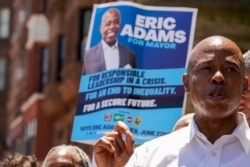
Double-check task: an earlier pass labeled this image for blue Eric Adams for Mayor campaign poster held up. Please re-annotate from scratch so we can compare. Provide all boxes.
[71,2,197,144]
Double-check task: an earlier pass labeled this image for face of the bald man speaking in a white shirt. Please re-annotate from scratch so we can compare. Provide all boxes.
[183,37,247,119]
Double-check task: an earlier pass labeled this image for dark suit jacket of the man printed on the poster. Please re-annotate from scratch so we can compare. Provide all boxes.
[83,42,136,74]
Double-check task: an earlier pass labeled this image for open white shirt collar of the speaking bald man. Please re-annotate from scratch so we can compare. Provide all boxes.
[188,112,250,154]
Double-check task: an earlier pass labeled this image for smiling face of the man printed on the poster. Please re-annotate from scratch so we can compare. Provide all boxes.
[100,10,120,45]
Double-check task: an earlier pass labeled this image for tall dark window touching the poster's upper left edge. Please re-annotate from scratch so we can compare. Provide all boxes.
[77,9,92,60]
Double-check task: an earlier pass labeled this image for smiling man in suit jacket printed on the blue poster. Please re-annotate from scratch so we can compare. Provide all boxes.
[83,8,136,74]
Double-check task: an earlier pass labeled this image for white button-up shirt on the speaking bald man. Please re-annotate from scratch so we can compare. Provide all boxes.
[126,113,250,167]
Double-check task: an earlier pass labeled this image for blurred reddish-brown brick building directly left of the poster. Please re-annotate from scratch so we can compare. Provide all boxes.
[7,0,115,159]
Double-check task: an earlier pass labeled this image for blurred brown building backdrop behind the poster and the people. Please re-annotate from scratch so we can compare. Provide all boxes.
[0,0,250,160]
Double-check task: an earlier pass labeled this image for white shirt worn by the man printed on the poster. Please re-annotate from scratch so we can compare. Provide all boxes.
[102,40,120,70]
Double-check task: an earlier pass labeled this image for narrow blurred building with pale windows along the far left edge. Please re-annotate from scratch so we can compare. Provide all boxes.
[0,0,12,158]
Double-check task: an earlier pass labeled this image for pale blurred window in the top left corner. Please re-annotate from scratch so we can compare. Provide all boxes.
[0,8,10,38]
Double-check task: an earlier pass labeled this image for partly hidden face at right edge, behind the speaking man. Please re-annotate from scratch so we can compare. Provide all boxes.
[239,71,250,126]
